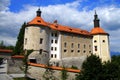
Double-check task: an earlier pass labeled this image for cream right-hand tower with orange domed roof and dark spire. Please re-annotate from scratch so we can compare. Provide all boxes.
[91,12,111,62]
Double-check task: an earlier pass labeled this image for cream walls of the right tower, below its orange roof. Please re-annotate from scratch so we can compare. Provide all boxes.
[93,35,110,62]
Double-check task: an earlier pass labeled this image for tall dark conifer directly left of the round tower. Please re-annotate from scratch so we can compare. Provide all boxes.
[13,23,26,55]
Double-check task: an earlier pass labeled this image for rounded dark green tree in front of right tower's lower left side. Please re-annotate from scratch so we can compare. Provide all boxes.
[76,54,102,80]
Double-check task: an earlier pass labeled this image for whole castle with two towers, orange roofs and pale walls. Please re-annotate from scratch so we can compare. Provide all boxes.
[24,9,110,64]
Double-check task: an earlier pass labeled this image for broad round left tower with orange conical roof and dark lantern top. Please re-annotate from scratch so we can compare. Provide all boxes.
[24,9,50,64]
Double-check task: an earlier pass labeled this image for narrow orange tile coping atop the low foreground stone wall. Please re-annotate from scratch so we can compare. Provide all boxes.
[28,63,80,73]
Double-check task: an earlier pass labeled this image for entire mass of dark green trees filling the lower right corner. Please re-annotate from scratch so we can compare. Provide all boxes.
[76,55,120,80]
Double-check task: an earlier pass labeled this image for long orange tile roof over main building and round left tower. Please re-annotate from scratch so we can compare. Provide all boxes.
[28,16,90,35]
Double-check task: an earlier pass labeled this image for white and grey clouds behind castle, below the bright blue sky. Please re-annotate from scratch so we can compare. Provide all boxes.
[0,1,120,52]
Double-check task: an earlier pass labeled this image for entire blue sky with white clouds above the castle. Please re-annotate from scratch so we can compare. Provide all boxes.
[0,0,120,54]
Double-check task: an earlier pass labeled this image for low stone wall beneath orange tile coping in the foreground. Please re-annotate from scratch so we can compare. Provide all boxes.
[28,66,78,80]
